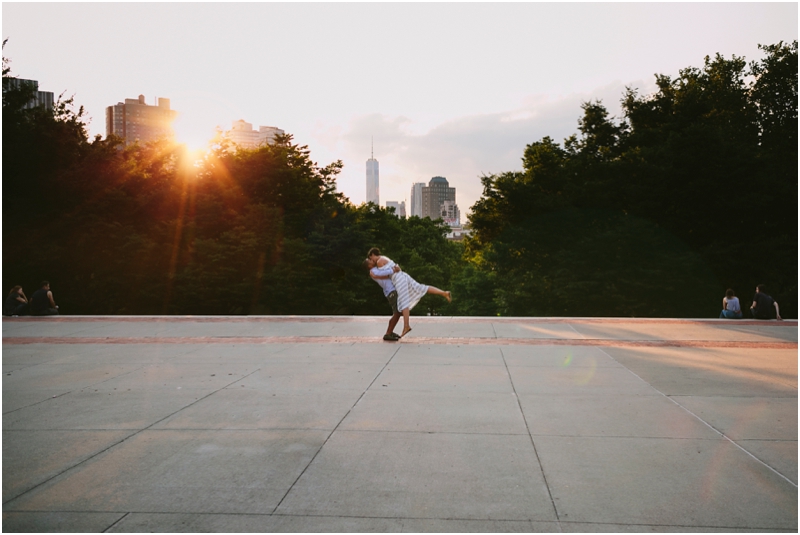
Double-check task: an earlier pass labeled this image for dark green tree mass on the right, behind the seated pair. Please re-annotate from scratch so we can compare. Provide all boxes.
[454,41,797,317]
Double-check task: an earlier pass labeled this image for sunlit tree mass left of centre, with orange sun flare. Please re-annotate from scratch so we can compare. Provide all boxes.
[3,45,461,315]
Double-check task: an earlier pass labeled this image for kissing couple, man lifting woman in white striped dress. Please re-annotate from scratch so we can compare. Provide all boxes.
[364,247,451,342]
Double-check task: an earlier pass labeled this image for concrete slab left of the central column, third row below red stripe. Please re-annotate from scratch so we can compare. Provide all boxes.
[152,385,361,431]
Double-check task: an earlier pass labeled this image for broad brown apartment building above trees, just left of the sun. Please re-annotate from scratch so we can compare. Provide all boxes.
[106,95,178,145]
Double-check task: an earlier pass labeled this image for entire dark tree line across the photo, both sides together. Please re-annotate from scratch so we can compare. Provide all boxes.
[3,42,797,317]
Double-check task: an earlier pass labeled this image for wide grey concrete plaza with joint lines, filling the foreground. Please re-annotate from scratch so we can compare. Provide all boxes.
[2,316,798,532]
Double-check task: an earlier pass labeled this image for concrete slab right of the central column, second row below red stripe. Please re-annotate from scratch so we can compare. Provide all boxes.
[508,366,660,396]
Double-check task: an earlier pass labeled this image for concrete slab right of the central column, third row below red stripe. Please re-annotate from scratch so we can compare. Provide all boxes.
[519,394,719,439]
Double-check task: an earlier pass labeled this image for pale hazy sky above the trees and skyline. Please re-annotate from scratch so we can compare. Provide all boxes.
[2,2,798,220]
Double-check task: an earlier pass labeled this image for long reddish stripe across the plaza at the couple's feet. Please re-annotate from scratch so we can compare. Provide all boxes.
[3,336,797,350]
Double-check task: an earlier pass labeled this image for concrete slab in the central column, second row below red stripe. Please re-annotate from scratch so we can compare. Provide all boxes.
[373,364,513,393]
